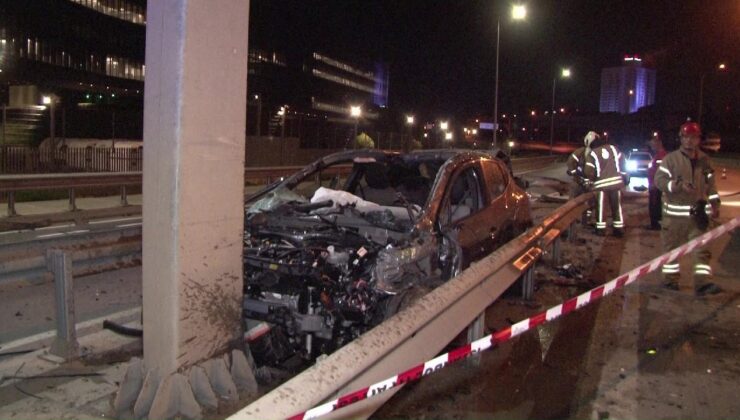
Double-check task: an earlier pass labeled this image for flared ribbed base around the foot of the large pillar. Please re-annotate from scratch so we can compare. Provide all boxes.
[113,350,259,420]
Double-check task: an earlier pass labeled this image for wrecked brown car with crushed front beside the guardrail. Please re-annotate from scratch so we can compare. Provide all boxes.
[244,150,532,367]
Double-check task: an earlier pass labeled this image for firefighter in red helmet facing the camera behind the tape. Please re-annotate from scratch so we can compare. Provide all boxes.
[655,121,720,296]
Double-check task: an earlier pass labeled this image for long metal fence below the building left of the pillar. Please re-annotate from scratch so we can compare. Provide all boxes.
[0,146,143,174]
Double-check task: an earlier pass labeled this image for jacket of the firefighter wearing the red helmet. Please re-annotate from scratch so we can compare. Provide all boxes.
[655,150,720,217]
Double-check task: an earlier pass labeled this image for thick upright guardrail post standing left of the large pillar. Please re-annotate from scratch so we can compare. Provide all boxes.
[46,249,80,360]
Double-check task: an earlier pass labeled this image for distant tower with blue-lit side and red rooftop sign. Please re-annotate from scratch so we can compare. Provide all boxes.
[599,56,655,114]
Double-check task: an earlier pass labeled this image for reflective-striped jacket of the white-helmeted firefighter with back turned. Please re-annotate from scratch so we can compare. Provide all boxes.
[584,139,625,191]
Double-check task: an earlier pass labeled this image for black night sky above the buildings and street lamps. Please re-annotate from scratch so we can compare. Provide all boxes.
[250,0,740,123]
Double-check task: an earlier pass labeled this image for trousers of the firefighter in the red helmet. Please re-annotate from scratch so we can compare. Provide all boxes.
[660,214,712,289]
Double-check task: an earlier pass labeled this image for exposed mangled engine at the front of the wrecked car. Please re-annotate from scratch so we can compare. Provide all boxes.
[244,203,416,366]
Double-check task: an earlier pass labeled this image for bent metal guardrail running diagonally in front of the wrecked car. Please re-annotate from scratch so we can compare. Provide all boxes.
[229,193,593,420]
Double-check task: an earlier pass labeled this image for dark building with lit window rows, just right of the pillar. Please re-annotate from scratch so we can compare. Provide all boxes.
[247,50,388,148]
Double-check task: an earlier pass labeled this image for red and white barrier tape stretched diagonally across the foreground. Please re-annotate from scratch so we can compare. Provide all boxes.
[289,217,740,420]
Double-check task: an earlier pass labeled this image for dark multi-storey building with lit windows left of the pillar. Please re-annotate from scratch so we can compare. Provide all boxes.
[0,0,146,145]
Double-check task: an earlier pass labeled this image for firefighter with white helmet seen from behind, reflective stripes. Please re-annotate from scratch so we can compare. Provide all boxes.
[585,131,627,238]
